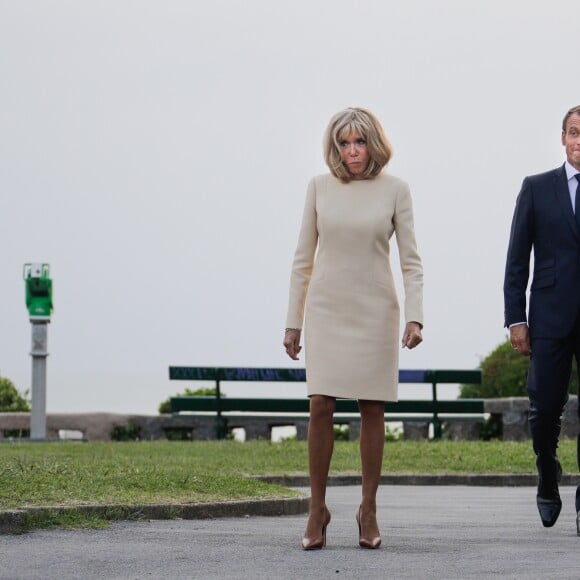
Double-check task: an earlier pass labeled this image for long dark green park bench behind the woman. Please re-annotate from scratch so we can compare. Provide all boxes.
[169,366,484,439]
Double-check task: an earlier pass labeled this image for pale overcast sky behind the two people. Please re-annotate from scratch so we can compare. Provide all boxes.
[0,0,580,413]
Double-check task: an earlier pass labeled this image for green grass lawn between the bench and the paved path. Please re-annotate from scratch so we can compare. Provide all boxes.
[0,440,576,532]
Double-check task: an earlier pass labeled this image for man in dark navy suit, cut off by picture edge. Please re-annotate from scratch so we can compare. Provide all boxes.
[504,106,580,535]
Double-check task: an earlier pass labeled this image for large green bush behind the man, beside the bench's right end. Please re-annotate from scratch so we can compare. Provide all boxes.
[459,339,578,399]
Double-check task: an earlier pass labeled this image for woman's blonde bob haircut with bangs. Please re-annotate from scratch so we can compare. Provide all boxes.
[323,107,393,183]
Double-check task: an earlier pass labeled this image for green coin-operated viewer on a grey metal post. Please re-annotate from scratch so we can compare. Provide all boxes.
[24,263,52,440]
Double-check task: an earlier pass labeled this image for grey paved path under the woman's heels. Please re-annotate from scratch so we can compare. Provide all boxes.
[0,486,580,580]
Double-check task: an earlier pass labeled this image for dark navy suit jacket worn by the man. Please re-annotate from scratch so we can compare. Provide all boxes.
[504,166,580,338]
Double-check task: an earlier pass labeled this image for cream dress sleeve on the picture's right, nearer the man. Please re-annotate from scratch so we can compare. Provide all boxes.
[394,184,423,325]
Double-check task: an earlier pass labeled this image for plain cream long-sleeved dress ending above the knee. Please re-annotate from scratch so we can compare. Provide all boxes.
[286,172,423,401]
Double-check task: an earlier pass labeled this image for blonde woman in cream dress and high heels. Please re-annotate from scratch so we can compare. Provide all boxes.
[284,108,423,550]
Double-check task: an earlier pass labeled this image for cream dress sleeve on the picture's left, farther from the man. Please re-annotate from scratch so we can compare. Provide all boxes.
[286,179,318,328]
